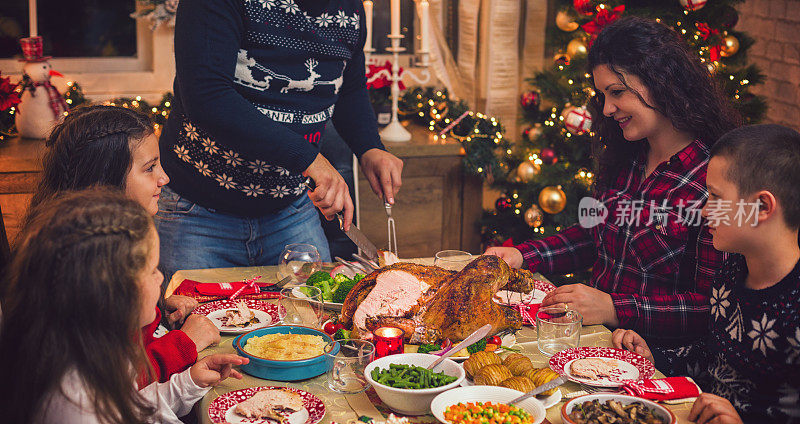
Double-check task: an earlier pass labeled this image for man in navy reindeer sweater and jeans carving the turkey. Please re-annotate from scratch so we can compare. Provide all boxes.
[157,0,403,280]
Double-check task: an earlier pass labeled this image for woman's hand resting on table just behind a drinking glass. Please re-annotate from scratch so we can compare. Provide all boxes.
[542,284,619,327]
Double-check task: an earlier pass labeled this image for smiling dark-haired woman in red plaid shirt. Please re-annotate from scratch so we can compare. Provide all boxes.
[486,17,737,362]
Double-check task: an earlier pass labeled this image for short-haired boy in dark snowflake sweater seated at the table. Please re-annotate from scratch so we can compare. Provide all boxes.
[613,125,800,423]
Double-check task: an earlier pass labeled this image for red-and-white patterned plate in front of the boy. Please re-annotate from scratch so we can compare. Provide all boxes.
[550,347,656,387]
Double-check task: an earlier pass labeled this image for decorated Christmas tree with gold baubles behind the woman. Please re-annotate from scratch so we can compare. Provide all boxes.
[481,0,766,284]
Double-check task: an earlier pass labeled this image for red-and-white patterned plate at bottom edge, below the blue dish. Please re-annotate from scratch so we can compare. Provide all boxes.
[208,386,325,424]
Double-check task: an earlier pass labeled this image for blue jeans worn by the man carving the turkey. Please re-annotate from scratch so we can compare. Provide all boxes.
[155,186,331,284]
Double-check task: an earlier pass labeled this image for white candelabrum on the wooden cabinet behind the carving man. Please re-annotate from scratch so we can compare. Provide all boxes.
[364,34,431,143]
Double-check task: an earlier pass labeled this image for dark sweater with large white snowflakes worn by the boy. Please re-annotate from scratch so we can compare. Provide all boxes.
[676,255,800,423]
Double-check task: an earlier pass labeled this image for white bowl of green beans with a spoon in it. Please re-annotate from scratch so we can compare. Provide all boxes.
[364,353,465,415]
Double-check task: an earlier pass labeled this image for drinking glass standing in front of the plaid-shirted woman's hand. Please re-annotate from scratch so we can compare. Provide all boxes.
[536,307,583,356]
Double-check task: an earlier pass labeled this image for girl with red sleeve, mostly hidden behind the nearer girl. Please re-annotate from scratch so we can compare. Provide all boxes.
[31,106,220,382]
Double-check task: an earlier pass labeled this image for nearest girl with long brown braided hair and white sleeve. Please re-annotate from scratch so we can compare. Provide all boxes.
[0,189,248,424]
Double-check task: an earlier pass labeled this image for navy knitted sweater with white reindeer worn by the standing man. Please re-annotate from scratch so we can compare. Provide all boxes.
[160,0,383,216]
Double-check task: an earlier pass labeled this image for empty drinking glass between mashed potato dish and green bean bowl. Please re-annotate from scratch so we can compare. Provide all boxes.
[325,339,375,394]
